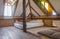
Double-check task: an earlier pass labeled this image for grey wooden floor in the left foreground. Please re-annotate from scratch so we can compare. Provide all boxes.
[0,27,40,39]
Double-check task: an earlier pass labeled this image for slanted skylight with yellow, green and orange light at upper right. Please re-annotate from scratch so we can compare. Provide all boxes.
[34,0,56,15]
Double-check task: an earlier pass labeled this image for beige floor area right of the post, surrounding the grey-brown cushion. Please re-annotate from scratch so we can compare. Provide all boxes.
[27,27,55,39]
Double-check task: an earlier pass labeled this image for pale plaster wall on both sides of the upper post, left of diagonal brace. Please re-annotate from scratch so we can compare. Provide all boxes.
[15,0,30,16]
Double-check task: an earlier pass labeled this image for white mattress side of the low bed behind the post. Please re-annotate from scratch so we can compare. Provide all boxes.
[14,23,43,28]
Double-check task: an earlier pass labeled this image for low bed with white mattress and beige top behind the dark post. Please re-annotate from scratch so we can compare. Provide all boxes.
[14,20,44,29]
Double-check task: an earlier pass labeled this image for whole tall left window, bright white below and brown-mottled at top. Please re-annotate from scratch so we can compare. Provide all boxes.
[4,0,16,16]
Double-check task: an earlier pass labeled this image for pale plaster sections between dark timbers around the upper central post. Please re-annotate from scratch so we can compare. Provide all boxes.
[14,0,45,16]
